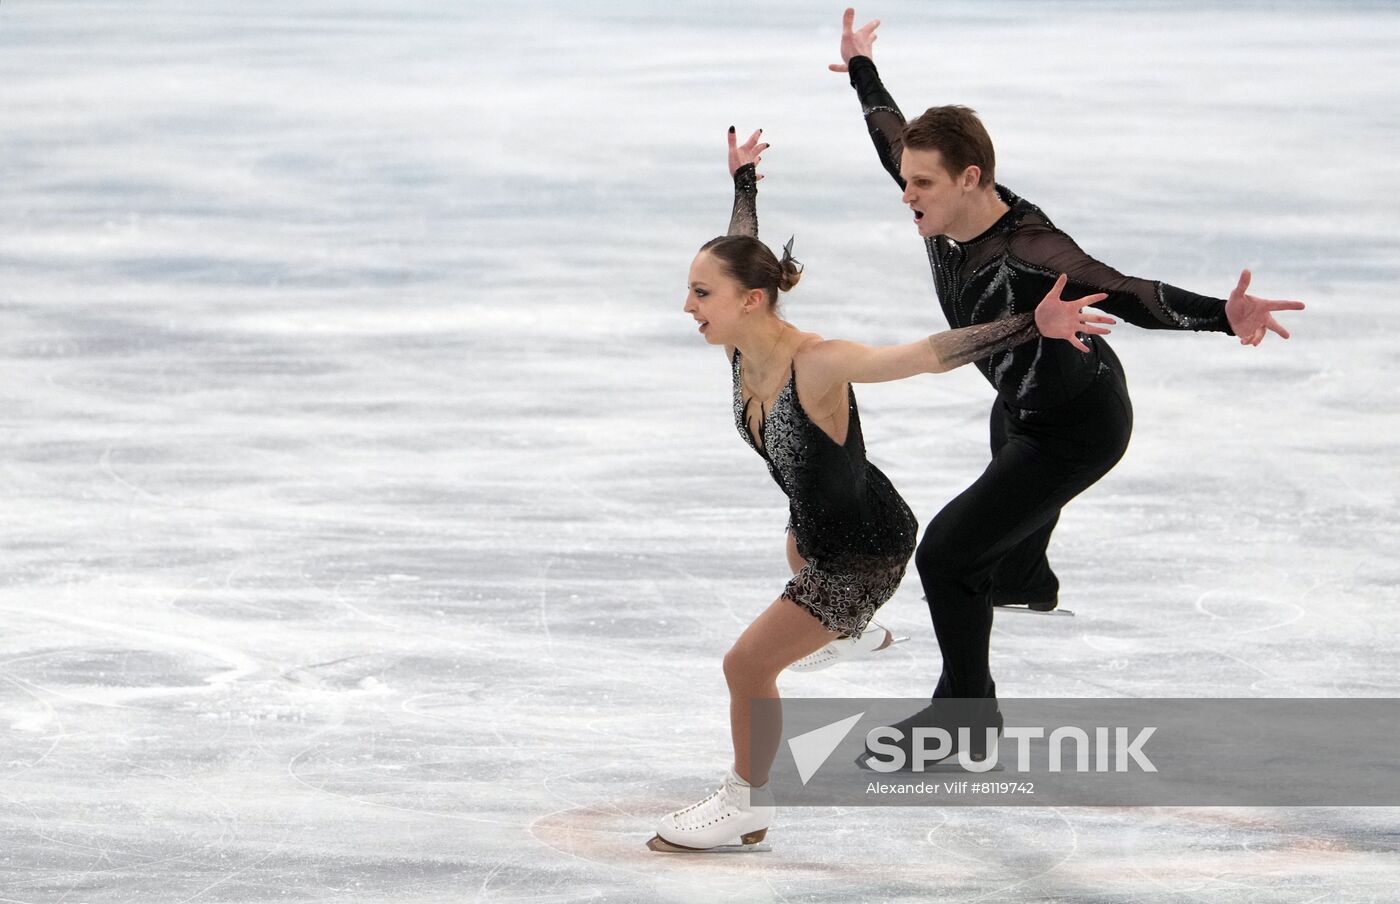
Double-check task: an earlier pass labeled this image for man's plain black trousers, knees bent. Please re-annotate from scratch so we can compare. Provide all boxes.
[914,354,1133,697]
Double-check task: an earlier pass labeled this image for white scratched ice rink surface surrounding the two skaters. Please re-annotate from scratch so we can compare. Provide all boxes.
[0,0,1400,904]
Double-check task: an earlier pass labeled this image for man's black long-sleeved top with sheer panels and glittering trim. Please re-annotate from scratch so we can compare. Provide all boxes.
[850,56,1231,409]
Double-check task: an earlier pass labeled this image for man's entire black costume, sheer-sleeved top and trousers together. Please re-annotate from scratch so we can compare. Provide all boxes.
[848,56,1231,697]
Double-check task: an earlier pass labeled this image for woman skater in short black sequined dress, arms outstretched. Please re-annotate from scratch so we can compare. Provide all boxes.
[648,127,1114,851]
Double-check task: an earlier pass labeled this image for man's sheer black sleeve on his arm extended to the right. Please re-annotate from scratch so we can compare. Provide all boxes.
[1011,225,1233,336]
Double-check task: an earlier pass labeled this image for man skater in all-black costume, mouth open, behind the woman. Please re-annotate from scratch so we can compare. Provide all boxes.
[830,10,1303,756]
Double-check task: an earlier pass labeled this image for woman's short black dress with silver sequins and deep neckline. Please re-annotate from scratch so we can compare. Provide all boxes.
[732,348,918,635]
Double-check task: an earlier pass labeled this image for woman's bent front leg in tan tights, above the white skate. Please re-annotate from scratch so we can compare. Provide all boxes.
[724,596,839,785]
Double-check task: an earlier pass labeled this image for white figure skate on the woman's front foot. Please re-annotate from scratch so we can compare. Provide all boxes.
[647,768,773,854]
